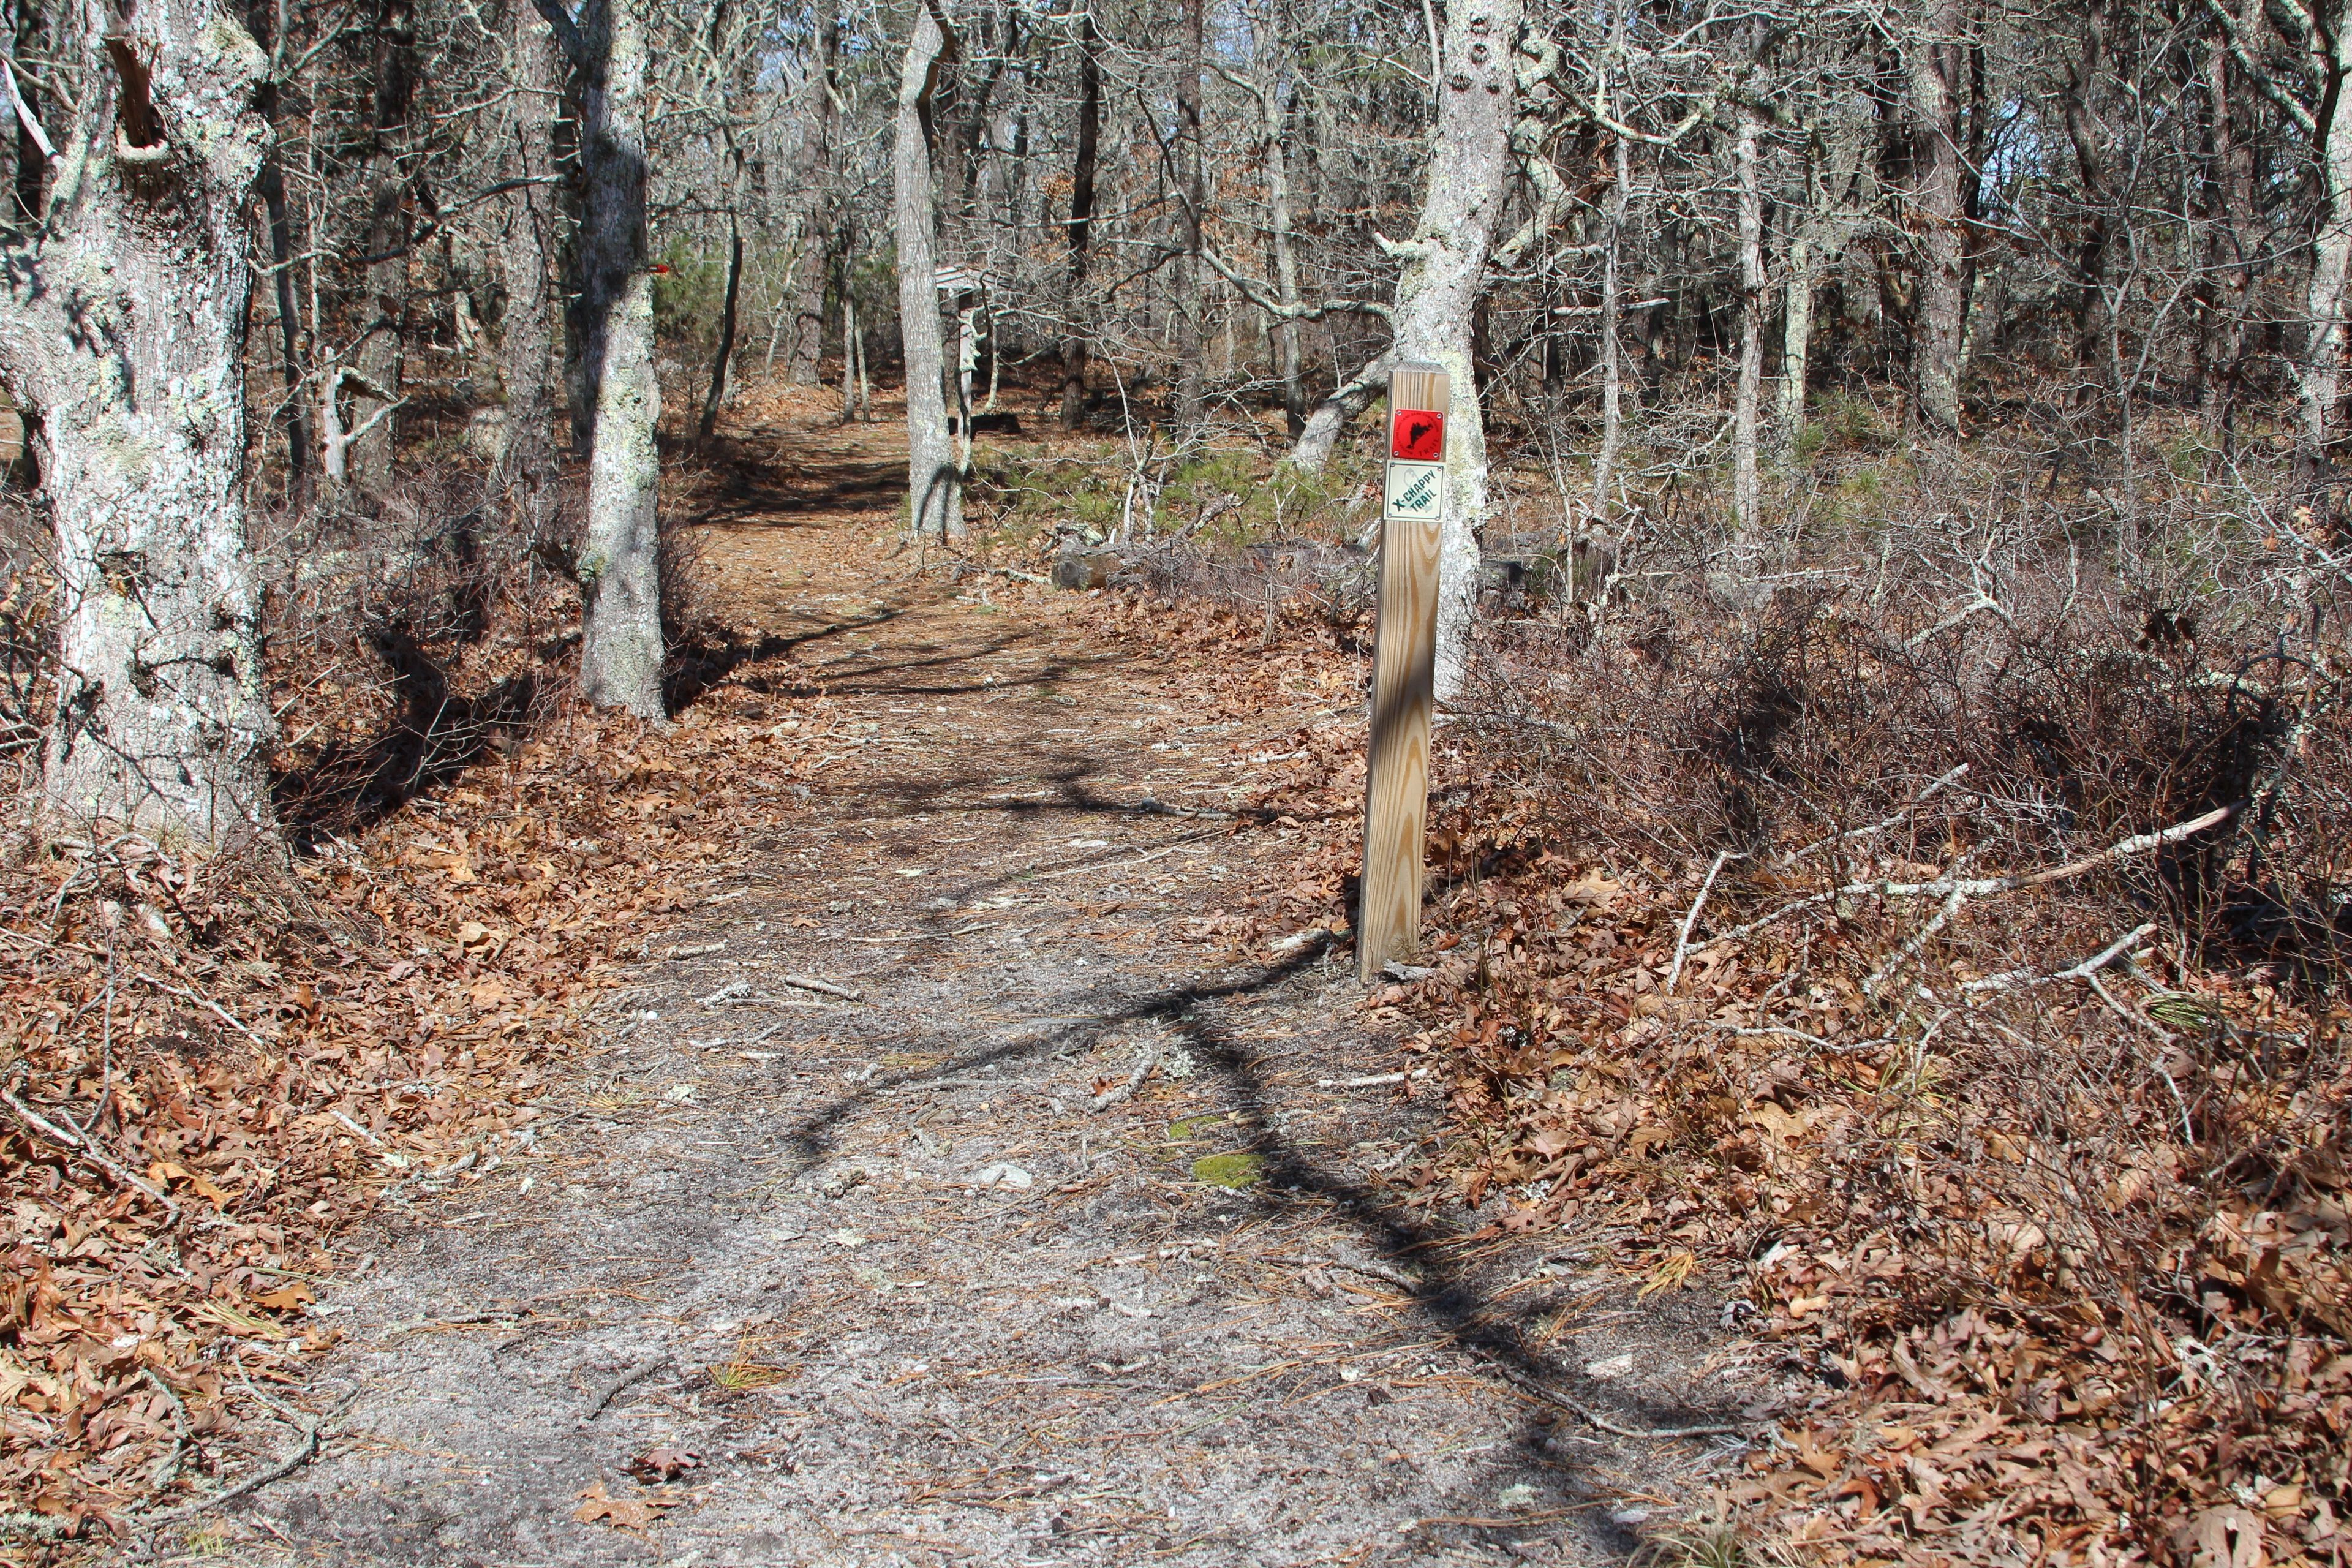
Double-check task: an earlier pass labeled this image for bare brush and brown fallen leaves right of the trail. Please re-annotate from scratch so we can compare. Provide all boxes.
[1411,481,2352,1566]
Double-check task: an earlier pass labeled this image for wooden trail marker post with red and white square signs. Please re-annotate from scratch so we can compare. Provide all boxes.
[1355,364,1453,985]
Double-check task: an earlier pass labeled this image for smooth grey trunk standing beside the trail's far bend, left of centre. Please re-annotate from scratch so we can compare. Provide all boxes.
[891,7,964,538]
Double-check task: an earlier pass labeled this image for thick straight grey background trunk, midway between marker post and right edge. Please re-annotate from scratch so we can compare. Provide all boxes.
[1903,0,1966,435]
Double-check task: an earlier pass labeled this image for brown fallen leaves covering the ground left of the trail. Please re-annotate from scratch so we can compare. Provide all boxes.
[0,665,831,1545]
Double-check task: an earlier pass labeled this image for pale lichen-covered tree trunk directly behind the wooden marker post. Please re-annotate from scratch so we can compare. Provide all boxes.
[1382,0,1521,701]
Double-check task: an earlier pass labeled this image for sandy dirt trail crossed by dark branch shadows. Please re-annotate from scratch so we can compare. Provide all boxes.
[214,409,1750,1568]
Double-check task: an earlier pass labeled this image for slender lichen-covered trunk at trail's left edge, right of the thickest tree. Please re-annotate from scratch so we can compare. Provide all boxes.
[581,0,666,722]
